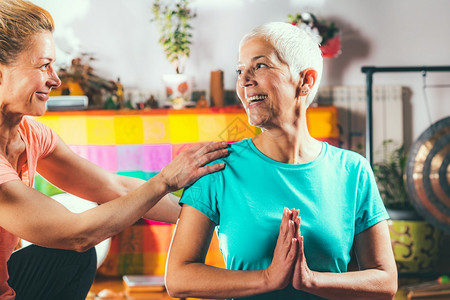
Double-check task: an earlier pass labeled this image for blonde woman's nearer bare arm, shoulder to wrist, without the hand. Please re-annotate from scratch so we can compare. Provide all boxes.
[0,171,167,251]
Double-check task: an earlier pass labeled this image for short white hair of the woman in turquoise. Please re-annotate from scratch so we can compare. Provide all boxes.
[239,22,323,106]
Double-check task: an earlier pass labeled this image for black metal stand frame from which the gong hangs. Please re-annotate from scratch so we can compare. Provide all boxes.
[361,66,450,165]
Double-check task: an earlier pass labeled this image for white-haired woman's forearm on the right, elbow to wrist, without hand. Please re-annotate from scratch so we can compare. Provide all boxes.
[304,269,397,300]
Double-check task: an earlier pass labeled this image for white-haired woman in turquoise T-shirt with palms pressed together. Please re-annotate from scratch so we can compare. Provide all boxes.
[166,22,397,300]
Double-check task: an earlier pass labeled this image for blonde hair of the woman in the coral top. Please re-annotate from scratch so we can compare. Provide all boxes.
[0,0,55,65]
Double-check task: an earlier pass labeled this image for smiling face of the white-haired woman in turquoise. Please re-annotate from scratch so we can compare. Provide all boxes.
[236,37,299,129]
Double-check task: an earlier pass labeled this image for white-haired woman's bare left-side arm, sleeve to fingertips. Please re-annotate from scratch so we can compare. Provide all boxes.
[166,205,297,298]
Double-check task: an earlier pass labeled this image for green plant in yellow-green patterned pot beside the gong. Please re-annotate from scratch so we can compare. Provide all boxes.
[373,140,442,273]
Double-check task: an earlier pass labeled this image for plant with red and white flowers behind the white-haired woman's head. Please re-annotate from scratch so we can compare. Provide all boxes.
[288,12,341,58]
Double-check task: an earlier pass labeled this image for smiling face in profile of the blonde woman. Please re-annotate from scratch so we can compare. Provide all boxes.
[0,32,61,116]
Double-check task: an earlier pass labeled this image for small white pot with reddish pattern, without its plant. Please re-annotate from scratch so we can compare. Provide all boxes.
[162,74,192,109]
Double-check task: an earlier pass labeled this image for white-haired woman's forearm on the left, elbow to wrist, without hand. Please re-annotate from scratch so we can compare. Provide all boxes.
[166,263,271,299]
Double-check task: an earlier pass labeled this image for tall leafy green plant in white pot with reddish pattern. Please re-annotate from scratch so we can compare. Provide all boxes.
[152,0,197,108]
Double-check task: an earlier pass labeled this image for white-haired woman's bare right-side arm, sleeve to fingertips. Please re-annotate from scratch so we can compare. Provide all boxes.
[293,221,397,299]
